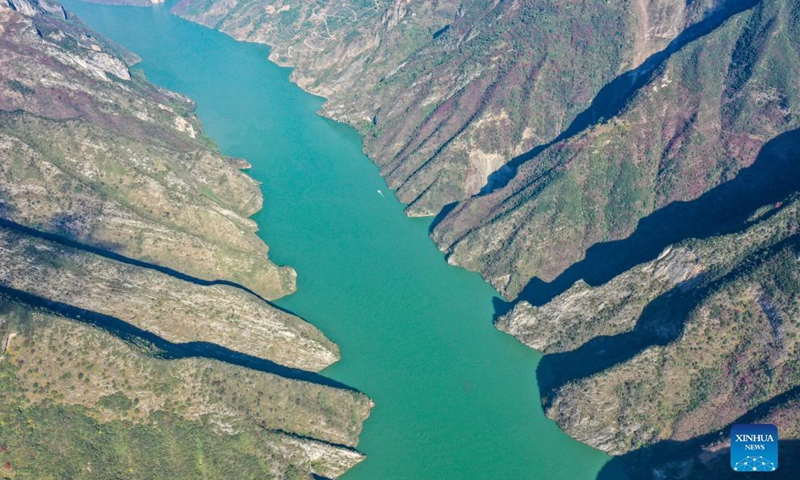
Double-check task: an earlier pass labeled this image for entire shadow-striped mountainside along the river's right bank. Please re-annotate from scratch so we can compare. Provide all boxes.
[164,0,800,478]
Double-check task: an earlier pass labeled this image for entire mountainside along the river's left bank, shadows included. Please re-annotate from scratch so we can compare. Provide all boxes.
[0,0,372,479]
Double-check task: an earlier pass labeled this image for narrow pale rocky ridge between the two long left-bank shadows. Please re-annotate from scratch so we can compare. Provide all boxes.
[0,227,339,371]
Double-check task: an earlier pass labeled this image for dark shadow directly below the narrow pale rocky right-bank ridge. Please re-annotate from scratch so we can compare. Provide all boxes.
[537,235,800,398]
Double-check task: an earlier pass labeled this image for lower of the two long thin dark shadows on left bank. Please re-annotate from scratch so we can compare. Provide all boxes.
[0,285,358,392]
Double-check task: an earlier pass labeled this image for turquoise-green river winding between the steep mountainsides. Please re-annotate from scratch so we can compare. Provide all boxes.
[65,1,620,480]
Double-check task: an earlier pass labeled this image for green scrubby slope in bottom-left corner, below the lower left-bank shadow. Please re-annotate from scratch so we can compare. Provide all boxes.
[0,294,370,480]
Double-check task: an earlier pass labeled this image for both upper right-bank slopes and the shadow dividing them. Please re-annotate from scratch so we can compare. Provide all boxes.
[167,0,797,298]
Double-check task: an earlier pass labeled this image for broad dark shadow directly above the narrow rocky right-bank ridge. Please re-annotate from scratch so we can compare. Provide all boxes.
[510,125,800,313]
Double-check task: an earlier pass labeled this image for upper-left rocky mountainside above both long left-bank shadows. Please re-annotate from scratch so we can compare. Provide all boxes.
[0,0,295,299]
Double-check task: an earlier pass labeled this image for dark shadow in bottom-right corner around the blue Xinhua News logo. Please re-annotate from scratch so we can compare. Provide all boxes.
[597,387,800,480]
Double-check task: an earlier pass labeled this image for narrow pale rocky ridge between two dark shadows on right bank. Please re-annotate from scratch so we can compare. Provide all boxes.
[497,197,800,353]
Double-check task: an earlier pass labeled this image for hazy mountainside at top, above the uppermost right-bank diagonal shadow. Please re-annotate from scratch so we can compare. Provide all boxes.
[173,0,719,215]
